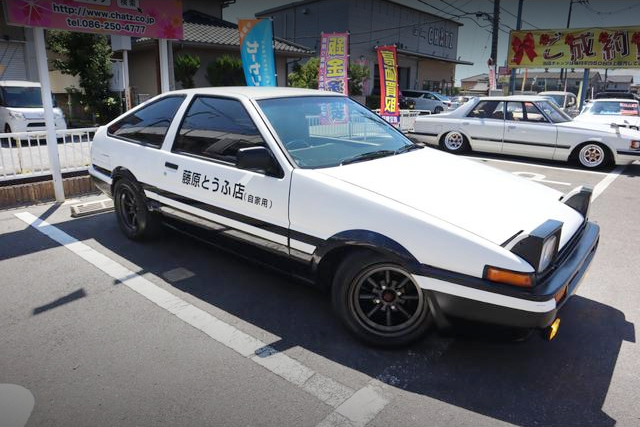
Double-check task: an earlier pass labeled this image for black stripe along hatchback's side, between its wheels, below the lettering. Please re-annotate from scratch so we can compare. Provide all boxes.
[142,184,324,246]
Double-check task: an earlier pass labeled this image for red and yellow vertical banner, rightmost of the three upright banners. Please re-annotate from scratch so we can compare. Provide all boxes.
[378,46,400,124]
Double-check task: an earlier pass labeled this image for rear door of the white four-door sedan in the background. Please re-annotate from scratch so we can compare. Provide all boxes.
[460,100,504,153]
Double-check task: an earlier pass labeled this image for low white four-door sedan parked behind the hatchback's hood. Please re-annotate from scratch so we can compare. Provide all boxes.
[410,96,640,168]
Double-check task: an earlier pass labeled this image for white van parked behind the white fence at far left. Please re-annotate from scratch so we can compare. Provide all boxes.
[0,80,67,133]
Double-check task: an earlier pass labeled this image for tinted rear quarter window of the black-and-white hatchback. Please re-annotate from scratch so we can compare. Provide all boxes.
[107,96,184,148]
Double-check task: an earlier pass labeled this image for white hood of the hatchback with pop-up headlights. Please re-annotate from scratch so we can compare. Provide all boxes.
[318,148,583,246]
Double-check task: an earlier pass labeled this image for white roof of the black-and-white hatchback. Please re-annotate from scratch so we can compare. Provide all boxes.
[161,86,346,99]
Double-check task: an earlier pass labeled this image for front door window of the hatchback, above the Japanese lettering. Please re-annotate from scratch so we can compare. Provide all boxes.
[171,96,265,165]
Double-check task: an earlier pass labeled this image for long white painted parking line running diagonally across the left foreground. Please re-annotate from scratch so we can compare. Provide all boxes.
[14,212,392,426]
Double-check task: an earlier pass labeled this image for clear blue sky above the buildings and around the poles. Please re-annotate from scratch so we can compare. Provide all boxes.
[223,0,640,85]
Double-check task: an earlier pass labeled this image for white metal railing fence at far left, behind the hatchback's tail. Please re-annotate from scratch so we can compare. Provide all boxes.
[0,128,97,181]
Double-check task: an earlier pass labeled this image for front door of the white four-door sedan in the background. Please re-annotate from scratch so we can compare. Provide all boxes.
[502,101,557,159]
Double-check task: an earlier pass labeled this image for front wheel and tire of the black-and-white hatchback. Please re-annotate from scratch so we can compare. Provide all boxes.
[331,251,433,347]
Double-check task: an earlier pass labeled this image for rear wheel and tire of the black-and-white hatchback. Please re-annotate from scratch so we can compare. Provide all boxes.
[113,178,161,240]
